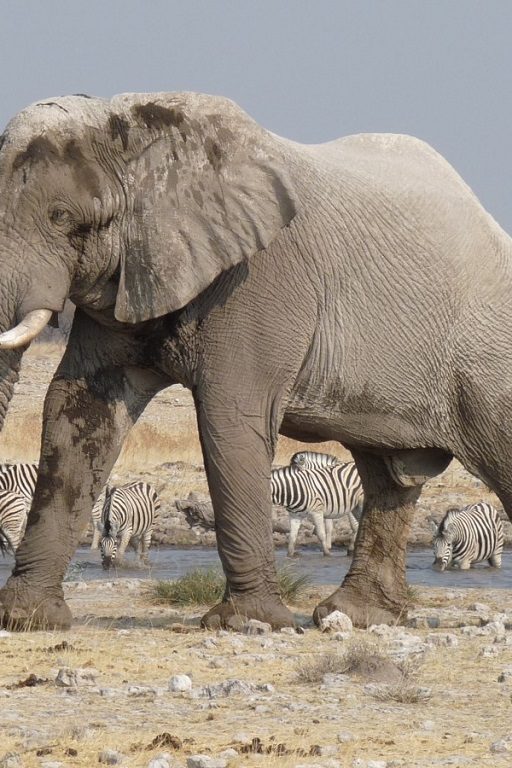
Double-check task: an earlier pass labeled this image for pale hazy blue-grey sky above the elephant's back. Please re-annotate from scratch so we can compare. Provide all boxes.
[0,0,512,234]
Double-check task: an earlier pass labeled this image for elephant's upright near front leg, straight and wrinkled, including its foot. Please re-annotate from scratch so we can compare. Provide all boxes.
[196,392,294,628]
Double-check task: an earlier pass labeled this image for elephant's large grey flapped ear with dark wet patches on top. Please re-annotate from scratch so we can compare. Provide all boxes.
[115,95,297,323]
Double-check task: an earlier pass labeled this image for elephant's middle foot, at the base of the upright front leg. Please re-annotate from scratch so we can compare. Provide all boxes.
[201,596,295,631]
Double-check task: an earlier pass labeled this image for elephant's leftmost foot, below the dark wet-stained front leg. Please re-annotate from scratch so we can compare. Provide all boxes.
[0,579,73,632]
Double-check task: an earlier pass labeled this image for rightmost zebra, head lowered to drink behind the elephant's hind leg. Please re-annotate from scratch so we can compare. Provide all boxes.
[432,501,503,571]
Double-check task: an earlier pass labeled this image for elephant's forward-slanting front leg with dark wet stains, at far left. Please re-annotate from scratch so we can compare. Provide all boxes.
[0,310,168,628]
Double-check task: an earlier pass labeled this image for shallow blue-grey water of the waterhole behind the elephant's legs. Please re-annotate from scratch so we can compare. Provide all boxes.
[0,547,512,589]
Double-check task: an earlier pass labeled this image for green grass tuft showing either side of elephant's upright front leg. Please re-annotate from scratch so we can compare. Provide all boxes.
[147,566,311,606]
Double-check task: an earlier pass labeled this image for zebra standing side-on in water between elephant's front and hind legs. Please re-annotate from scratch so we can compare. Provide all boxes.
[271,462,363,557]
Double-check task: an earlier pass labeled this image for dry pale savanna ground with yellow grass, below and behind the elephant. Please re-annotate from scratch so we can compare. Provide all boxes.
[0,343,512,768]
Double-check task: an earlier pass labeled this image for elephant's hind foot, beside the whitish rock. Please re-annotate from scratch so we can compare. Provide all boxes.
[313,586,407,629]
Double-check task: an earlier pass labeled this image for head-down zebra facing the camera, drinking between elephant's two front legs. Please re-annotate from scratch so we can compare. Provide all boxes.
[100,482,160,570]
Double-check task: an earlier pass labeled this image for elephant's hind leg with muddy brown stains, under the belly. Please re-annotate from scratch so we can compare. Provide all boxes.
[314,451,422,627]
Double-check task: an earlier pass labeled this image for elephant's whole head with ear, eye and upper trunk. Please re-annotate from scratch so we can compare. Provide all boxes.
[0,93,296,426]
